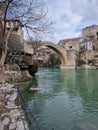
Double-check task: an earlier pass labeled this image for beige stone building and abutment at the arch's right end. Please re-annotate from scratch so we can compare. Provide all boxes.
[58,37,81,68]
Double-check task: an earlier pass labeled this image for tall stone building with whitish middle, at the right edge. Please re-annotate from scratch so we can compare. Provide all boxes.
[79,25,98,64]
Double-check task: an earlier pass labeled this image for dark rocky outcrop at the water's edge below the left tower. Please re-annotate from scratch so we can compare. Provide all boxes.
[5,51,38,82]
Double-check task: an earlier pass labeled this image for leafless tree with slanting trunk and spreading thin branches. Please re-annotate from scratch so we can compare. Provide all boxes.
[0,0,51,83]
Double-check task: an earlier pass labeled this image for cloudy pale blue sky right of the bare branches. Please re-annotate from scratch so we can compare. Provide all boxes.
[44,0,98,44]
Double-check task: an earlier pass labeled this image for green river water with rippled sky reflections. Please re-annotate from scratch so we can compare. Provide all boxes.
[20,69,98,130]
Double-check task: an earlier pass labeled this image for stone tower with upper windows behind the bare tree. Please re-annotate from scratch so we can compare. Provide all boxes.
[6,20,24,51]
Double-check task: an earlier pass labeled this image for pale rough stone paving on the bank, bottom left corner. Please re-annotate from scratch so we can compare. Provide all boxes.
[0,84,29,130]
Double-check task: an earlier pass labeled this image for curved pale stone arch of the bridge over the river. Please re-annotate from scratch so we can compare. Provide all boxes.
[40,41,67,68]
